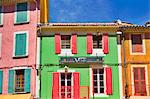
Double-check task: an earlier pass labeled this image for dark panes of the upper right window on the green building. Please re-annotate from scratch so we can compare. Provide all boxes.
[93,35,102,49]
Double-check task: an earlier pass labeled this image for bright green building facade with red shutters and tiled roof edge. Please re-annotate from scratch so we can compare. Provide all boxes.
[38,23,120,99]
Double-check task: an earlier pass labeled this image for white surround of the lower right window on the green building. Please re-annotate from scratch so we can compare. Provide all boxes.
[89,64,108,97]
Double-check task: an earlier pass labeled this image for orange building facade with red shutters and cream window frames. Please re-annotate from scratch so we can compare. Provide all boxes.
[120,26,150,99]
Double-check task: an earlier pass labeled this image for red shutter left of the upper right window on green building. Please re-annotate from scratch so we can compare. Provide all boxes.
[87,34,93,54]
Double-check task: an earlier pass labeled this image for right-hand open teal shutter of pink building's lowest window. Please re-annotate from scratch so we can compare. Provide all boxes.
[24,69,31,92]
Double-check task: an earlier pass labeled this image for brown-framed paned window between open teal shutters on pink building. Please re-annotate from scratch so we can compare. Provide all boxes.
[15,69,24,92]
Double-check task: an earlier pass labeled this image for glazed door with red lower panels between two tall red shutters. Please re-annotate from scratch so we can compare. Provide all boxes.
[61,73,72,99]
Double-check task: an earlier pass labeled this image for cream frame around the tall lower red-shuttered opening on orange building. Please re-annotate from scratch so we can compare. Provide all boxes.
[131,64,149,96]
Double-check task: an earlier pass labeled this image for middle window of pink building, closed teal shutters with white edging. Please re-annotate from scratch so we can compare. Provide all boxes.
[14,32,28,57]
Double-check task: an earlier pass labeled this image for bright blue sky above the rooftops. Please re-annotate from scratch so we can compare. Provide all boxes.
[49,0,150,25]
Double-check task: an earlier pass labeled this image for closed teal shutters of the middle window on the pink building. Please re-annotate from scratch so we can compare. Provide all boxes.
[15,33,27,56]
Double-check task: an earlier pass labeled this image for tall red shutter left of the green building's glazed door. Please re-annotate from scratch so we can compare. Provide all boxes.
[52,72,59,99]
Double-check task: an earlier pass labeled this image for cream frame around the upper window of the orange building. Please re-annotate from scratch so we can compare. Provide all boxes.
[129,33,146,55]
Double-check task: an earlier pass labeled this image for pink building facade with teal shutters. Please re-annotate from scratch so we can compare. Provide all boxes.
[0,0,39,97]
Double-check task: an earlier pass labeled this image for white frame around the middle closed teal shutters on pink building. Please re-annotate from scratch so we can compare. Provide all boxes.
[13,31,29,58]
